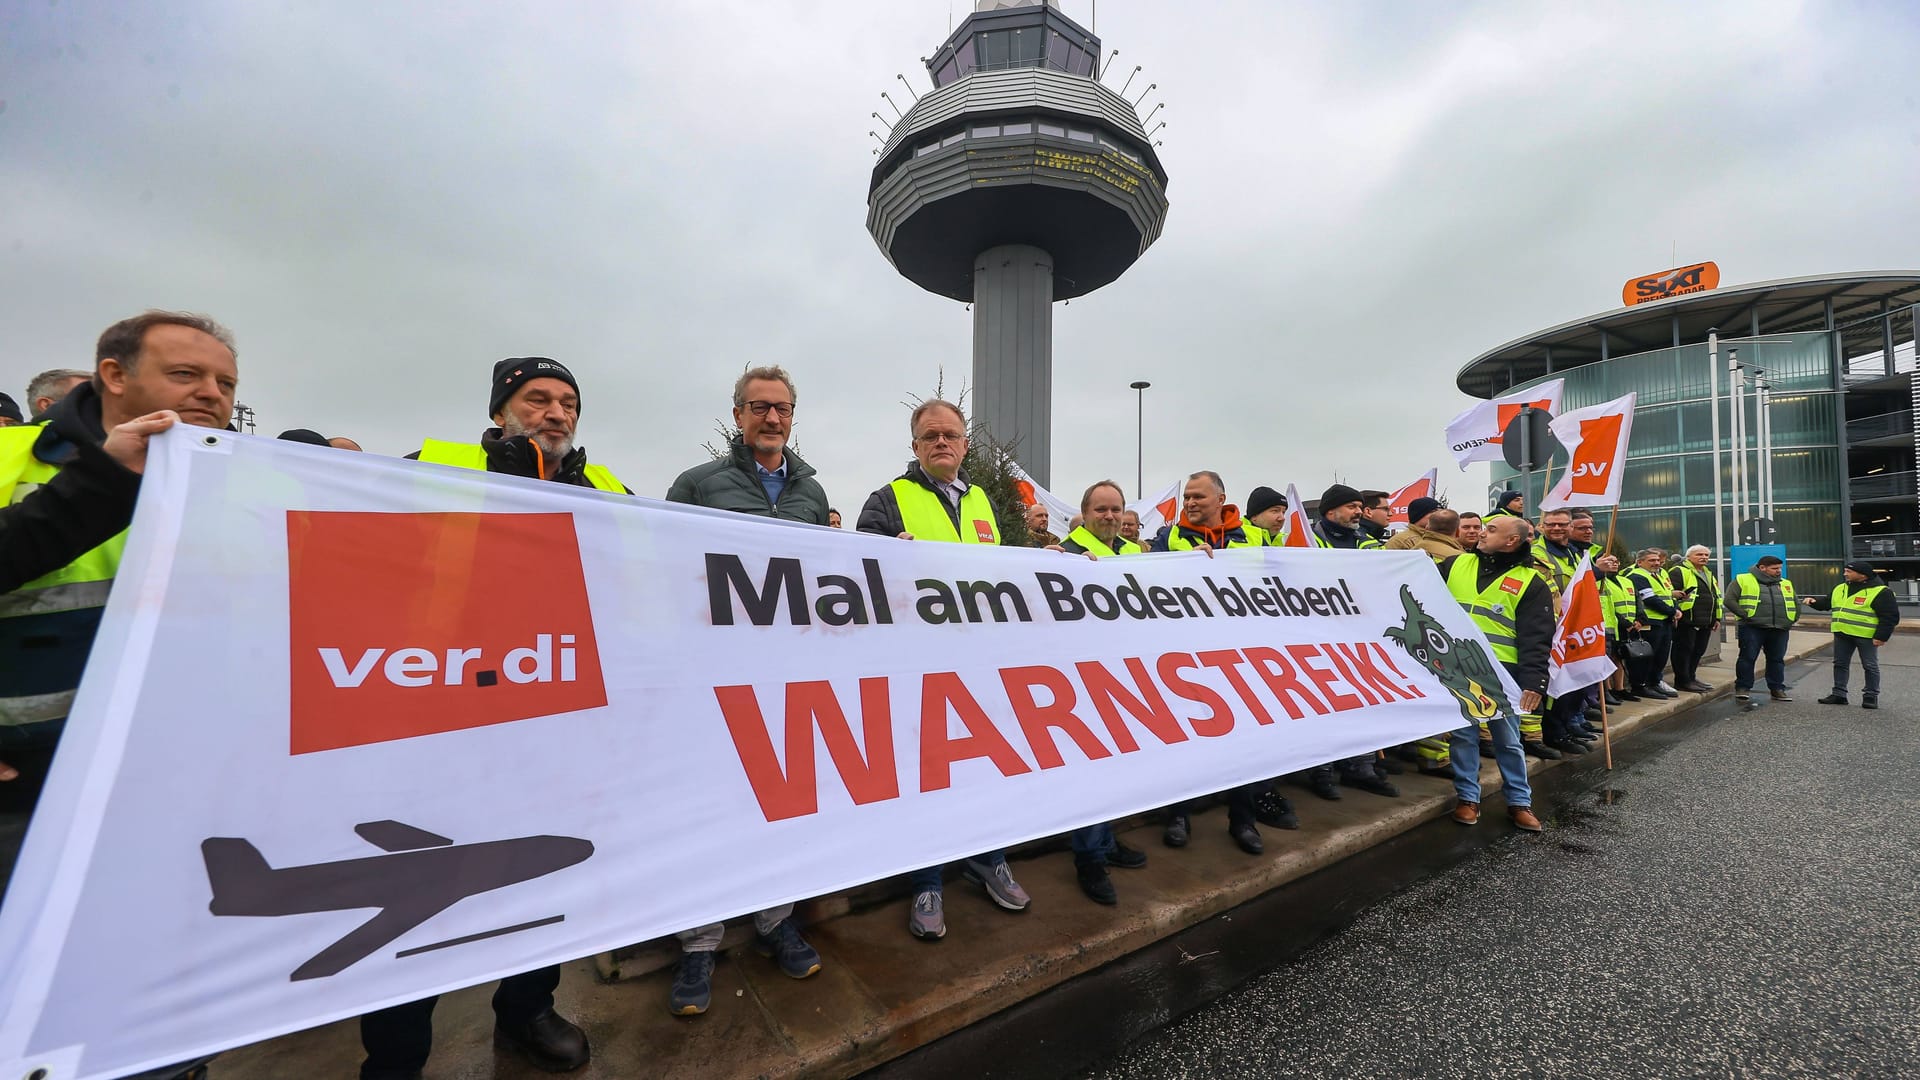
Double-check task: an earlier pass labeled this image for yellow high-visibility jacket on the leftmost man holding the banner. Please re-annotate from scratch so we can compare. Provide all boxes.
[0,425,127,730]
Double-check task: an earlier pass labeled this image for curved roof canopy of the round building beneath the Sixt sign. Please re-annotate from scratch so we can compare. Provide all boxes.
[1455,271,1920,398]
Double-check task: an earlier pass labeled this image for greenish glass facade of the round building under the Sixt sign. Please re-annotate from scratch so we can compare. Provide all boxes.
[1492,331,1847,592]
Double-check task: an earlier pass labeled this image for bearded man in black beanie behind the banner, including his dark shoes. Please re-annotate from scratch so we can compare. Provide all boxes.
[361,356,618,1080]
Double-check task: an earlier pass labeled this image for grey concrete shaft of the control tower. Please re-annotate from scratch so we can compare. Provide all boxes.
[972,244,1054,488]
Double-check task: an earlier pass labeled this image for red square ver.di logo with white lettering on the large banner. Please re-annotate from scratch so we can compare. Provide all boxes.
[286,511,607,753]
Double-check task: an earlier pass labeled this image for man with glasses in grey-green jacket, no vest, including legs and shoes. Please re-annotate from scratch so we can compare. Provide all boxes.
[666,365,833,1017]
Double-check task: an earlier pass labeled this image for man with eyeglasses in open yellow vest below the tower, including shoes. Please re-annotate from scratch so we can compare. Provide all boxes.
[858,398,1033,942]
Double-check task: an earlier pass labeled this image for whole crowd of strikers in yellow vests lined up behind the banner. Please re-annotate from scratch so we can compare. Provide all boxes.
[0,311,1899,1080]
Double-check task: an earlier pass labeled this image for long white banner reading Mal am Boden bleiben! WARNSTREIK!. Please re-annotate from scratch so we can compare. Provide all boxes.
[0,429,1517,1080]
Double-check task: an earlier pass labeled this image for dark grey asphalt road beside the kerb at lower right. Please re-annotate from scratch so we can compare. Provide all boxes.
[1083,636,1920,1080]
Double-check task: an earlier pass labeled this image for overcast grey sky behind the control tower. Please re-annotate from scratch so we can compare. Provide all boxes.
[0,0,1920,511]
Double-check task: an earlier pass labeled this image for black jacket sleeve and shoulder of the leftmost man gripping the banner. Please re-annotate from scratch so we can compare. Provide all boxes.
[0,382,140,592]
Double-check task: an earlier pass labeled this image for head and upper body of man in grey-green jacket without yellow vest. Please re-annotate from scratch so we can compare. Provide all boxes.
[666,365,831,525]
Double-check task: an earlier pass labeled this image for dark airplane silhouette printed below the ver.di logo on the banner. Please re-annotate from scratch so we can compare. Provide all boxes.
[200,821,593,982]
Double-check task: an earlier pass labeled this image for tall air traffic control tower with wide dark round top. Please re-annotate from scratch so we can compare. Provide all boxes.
[866,0,1167,480]
